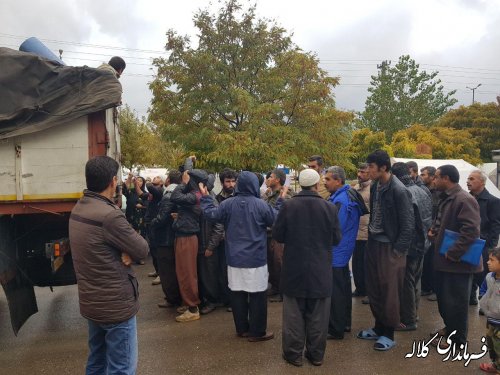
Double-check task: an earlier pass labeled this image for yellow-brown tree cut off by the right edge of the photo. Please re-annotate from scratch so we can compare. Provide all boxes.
[437,103,500,162]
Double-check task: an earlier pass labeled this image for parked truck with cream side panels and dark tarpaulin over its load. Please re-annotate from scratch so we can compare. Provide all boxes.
[0,48,122,335]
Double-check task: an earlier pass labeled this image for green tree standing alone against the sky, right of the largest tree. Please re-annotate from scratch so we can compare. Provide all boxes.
[362,55,457,140]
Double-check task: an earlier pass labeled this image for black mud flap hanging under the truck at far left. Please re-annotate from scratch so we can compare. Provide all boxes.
[2,277,38,336]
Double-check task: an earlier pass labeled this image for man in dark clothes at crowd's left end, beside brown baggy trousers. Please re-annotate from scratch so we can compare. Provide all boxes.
[151,169,182,307]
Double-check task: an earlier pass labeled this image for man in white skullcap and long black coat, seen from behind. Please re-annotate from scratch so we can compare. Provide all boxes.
[273,169,341,366]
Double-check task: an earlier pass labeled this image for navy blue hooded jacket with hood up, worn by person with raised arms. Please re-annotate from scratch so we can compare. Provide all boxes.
[201,171,283,268]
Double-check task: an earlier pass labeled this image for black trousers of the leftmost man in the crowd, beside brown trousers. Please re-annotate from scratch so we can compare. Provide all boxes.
[157,245,182,305]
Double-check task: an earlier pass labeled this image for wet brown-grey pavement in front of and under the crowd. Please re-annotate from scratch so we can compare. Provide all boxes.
[0,263,489,375]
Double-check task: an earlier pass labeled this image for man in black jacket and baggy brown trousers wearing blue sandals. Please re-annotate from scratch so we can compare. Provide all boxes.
[358,150,415,351]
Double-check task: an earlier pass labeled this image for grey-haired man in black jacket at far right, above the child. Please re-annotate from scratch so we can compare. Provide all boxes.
[467,170,500,305]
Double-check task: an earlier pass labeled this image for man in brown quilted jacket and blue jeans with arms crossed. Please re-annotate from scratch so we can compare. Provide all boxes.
[69,156,149,374]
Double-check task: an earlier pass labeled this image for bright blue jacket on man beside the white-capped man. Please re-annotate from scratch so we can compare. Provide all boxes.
[328,185,362,267]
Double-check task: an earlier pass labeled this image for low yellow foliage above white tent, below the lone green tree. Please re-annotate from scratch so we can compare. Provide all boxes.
[391,124,481,165]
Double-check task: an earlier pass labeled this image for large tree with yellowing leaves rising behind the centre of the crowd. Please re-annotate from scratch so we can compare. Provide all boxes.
[149,0,353,170]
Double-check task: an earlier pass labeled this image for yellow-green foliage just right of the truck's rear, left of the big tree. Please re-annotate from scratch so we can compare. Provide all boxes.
[118,106,182,169]
